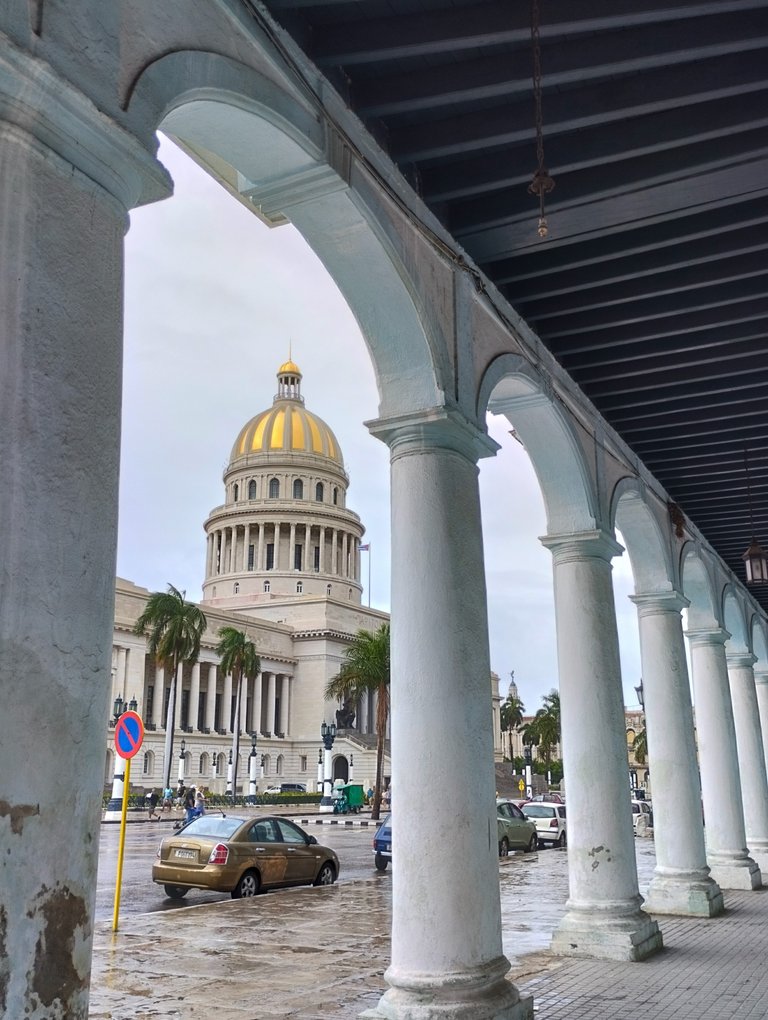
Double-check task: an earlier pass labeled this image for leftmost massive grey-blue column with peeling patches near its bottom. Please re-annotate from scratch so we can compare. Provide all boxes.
[0,51,167,1020]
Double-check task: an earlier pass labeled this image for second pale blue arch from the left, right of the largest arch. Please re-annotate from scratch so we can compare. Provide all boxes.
[477,354,603,534]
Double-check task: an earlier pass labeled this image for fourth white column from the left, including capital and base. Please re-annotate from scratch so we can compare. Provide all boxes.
[632,592,723,917]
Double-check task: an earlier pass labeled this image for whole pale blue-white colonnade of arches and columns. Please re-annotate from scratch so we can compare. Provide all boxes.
[0,9,768,1020]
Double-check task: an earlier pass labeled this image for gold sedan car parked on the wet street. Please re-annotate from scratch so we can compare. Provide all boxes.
[152,814,339,900]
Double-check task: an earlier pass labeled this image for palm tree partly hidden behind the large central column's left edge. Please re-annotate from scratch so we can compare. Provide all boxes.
[325,623,390,819]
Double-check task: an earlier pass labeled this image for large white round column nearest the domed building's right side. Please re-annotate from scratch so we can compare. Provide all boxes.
[363,412,532,1020]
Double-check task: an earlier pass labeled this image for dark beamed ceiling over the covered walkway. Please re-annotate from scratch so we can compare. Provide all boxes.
[256,0,768,609]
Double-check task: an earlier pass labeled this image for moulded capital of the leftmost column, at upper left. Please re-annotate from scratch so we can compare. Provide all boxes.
[0,37,173,209]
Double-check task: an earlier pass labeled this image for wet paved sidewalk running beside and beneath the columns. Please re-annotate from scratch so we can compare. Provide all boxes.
[90,860,768,1020]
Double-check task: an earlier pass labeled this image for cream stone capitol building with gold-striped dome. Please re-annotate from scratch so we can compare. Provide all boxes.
[104,360,390,794]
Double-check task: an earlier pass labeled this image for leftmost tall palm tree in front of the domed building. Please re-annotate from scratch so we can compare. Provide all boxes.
[134,584,207,789]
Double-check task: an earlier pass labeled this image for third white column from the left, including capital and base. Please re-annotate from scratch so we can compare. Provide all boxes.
[542,530,662,961]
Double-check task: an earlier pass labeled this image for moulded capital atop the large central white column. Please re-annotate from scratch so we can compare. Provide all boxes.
[365,407,501,464]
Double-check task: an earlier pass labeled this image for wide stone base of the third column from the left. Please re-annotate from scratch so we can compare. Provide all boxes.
[550,897,664,963]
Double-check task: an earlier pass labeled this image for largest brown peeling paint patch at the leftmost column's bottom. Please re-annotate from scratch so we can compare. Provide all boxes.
[28,886,92,1020]
